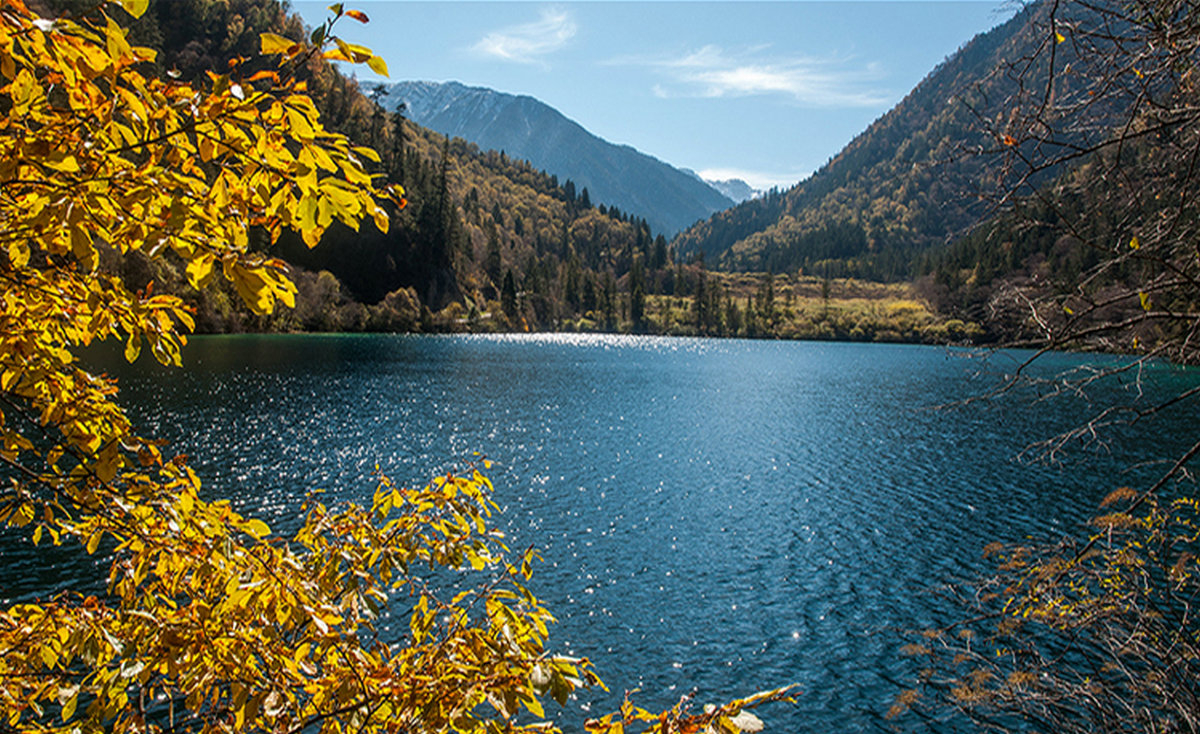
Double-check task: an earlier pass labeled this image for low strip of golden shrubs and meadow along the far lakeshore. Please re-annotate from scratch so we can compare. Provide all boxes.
[177,257,997,344]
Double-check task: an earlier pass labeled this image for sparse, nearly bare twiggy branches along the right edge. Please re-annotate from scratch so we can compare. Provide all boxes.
[894,0,1200,732]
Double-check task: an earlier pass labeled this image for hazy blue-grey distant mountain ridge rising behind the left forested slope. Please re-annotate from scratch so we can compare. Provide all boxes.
[383,82,734,236]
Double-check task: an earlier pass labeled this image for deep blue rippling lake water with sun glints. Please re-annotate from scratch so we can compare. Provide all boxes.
[0,336,1198,732]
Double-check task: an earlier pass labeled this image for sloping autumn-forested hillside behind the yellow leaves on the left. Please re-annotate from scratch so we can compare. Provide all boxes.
[52,0,673,331]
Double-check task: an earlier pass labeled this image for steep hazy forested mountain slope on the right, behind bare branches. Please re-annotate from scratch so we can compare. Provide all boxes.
[674,4,1069,279]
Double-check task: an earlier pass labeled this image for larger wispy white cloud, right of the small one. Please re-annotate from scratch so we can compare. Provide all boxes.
[612,46,889,107]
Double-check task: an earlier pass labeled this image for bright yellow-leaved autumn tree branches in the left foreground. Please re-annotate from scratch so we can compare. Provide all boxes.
[0,0,786,733]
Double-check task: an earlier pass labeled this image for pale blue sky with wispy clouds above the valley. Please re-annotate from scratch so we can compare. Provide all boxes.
[293,0,1012,187]
